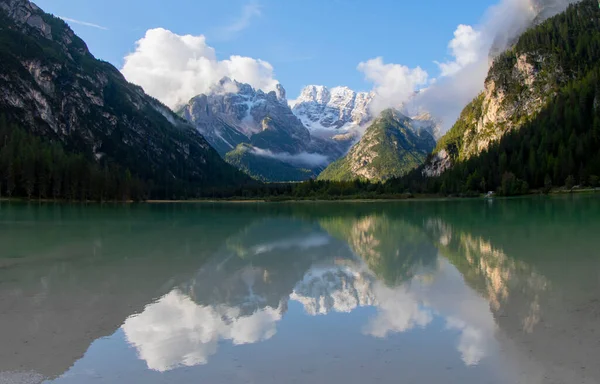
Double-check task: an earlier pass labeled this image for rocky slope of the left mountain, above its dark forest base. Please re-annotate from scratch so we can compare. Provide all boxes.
[0,0,245,190]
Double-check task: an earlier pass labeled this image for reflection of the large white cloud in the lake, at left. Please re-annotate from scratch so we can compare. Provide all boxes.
[122,290,282,372]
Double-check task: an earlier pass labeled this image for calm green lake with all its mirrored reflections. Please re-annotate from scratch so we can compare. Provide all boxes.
[0,196,600,384]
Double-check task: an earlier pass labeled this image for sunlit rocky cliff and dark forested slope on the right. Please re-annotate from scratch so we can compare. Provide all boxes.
[408,0,600,193]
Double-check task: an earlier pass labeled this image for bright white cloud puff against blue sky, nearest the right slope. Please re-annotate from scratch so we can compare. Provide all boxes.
[436,24,482,76]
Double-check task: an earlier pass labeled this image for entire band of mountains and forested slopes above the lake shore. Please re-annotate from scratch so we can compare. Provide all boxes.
[0,0,600,200]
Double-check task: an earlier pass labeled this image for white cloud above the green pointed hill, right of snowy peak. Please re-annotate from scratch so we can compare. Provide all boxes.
[358,57,429,115]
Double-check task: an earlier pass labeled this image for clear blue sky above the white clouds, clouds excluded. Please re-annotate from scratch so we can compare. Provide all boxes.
[31,0,494,98]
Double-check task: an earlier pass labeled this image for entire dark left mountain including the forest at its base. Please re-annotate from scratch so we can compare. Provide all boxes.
[0,0,248,199]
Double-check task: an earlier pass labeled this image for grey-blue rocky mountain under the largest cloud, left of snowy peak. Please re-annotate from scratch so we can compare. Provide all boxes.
[179,78,354,182]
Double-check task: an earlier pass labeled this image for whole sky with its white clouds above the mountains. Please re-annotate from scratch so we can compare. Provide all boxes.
[32,0,556,131]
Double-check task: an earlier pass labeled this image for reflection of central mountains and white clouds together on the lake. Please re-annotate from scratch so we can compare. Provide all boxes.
[115,215,490,372]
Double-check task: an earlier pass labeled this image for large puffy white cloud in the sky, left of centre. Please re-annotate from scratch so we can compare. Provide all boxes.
[121,28,278,109]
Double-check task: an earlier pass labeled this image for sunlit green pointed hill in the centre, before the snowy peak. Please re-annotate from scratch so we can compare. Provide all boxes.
[319,110,435,181]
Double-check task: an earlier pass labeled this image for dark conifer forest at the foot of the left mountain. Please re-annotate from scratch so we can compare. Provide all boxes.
[0,116,149,201]
